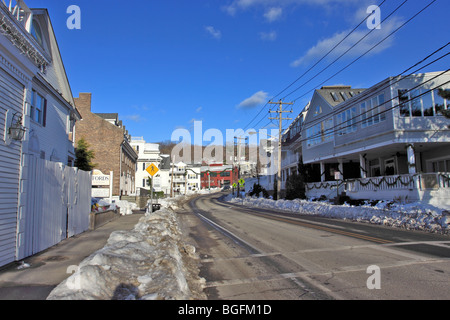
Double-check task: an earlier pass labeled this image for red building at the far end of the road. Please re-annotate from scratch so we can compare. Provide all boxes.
[200,163,238,189]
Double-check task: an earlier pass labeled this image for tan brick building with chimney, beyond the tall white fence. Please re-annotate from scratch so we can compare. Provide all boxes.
[74,93,138,196]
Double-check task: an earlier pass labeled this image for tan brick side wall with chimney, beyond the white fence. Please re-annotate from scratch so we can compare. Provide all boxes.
[74,93,137,196]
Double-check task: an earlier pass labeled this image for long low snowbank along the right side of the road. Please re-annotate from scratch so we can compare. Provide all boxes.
[229,195,450,234]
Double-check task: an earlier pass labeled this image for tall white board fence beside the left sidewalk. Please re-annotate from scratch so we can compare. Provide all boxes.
[17,156,92,260]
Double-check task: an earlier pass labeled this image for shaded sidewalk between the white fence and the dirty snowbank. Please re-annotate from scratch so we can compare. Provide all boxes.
[0,211,144,300]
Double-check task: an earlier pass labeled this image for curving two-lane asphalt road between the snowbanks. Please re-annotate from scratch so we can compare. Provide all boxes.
[179,193,450,300]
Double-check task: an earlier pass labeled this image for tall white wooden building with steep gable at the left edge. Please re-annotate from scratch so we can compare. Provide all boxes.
[0,0,86,267]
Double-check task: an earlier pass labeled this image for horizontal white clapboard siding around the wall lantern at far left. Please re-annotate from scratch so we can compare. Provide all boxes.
[0,68,24,266]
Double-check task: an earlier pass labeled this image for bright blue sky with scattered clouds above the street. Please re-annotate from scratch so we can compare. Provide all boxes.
[25,0,450,145]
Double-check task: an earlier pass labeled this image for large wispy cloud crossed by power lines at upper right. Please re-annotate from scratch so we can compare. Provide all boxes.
[291,17,402,67]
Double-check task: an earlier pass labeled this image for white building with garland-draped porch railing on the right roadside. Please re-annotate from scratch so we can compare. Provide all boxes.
[302,72,450,203]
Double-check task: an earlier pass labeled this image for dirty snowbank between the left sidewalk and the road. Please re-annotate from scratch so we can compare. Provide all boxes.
[47,208,205,300]
